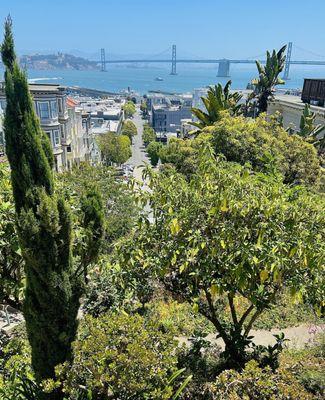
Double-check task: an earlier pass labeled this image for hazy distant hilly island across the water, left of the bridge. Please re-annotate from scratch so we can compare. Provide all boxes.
[20,53,99,70]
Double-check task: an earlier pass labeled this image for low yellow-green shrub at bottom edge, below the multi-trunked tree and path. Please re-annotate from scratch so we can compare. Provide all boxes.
[205,361,312,400]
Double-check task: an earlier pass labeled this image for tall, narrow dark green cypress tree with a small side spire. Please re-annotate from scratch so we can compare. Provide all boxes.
[1,17,103,399]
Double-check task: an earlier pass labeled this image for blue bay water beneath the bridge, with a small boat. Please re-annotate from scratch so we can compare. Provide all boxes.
[23,64,325,94]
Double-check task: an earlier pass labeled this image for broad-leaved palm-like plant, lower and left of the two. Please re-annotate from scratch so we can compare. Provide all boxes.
[191,81,242,129]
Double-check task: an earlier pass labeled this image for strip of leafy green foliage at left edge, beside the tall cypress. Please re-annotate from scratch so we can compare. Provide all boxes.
[0,162,23,308]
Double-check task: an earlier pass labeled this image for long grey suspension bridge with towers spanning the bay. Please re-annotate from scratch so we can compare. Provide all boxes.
[96,42,325,80]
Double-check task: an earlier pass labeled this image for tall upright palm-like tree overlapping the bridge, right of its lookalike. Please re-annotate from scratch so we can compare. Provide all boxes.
[252,46,287,113]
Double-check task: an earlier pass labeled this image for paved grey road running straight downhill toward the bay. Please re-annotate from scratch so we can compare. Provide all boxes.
[127,107,149,180]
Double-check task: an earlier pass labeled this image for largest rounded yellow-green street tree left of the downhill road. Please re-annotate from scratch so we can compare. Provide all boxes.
[98,132,132,165]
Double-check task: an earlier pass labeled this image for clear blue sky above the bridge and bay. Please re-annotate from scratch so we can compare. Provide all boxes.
[0,0,325,58]
